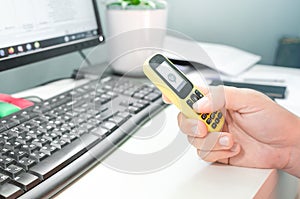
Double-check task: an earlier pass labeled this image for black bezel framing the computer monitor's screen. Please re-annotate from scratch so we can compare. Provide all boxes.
[0,0,105,72]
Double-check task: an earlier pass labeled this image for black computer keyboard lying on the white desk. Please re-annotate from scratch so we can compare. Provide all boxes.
[0,77,163,198]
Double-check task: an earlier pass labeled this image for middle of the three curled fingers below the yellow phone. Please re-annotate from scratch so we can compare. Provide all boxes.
[188,132,233,152]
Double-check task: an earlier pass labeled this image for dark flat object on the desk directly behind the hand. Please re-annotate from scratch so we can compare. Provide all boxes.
[211,81,286,100]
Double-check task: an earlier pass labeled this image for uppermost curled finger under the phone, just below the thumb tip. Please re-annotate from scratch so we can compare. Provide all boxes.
[177,113,207,137]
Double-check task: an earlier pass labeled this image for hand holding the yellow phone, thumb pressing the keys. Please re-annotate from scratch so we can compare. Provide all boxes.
[164,87,300,177]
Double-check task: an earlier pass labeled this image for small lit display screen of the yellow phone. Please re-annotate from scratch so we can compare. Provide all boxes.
[156,61,187,92]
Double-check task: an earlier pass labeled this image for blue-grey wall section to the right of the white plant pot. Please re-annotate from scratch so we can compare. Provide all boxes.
[168,0,300,64]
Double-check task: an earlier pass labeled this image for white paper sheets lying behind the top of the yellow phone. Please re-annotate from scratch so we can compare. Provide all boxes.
[164,36,261,76]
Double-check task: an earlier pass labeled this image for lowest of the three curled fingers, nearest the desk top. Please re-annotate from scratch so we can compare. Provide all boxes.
[197,144,241,162]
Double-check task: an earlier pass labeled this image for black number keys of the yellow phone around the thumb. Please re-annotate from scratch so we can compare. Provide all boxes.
[186,89,223,129]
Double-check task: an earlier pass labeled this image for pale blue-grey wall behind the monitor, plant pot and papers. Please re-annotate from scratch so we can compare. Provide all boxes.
[0,0,300,93]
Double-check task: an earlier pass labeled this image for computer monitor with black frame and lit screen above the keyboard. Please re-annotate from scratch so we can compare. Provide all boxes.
[0,0,104,71]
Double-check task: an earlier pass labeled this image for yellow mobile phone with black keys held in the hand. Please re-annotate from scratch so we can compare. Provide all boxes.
[143,54,224,132]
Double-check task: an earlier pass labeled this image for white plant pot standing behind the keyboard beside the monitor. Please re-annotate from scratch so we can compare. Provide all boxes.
[106,9,167,76]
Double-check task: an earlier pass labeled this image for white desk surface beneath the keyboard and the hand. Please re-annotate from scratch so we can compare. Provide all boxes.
[18,65,300,199]
